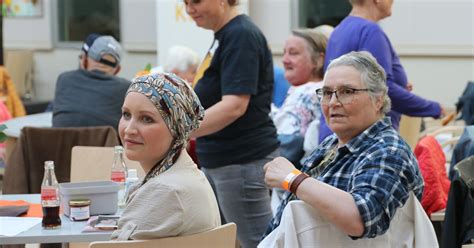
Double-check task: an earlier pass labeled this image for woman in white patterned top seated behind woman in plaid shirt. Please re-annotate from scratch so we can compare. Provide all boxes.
[272,25,333,168]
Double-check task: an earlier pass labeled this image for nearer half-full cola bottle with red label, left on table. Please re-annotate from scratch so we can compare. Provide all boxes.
[41,161,61,229]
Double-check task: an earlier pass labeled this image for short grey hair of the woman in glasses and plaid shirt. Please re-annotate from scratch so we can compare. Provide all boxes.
[326,51,391,114]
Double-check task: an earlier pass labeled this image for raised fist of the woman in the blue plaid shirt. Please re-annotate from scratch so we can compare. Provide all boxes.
[263,157,296,188]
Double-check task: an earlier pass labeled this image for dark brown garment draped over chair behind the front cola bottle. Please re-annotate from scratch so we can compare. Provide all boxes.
[3,126,119,194]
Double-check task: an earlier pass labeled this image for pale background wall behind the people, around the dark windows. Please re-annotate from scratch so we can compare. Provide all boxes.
[4,0,474,107]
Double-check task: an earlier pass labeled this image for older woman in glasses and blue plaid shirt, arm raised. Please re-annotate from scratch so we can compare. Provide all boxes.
[264,52,423,244]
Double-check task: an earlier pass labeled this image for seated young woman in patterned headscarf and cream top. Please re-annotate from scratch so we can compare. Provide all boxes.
[112,73,220,240]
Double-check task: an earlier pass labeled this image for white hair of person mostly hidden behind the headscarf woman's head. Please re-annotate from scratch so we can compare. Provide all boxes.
[163,46,199,72]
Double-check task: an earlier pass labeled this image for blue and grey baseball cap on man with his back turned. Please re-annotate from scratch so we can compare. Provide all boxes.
[82,34,122,67]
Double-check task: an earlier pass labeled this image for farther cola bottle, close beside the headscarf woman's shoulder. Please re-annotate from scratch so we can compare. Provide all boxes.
[110,146,127,207]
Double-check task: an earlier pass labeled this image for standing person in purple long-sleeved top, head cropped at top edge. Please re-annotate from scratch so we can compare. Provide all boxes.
[319,0,444,141]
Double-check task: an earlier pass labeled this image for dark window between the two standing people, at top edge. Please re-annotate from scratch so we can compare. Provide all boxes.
[298,0,351,28]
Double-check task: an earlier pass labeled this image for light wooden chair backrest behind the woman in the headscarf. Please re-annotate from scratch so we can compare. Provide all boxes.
[89,223,237,248]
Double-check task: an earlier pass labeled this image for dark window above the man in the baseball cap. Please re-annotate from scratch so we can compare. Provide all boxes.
[57,0,120,42]
